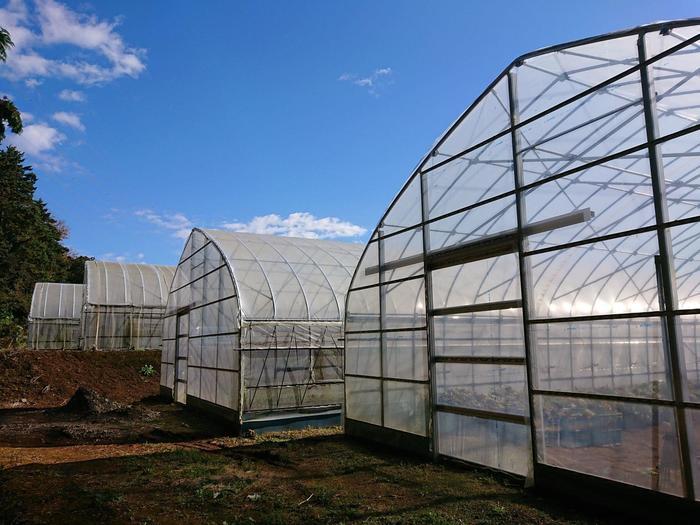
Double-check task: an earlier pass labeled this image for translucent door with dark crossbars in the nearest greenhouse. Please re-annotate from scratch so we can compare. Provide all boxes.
[428,239,531,475]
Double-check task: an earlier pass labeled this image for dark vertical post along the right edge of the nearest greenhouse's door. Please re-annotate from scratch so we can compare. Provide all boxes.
[508,64,537,485]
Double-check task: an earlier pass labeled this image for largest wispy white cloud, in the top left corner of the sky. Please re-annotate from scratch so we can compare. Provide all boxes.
[0,0,146,84]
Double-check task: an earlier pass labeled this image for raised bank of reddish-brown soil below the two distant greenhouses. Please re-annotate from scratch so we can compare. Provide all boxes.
[0,350,160,408]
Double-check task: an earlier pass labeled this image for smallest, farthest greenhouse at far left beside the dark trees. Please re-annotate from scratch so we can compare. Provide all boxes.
[27,283,83,350]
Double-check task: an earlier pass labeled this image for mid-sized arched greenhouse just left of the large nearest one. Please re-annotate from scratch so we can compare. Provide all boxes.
[161,229,363,431]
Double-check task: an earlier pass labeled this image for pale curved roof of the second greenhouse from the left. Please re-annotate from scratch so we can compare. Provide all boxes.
[85,261,175,308]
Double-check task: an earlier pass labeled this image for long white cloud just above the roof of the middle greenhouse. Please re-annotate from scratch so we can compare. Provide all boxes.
[222,212,367,239]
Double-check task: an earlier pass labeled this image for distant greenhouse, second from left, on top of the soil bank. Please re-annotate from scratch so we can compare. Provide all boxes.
[80,261,175,350]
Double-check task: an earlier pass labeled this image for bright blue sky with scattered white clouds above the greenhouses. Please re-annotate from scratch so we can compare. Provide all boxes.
[0,0,700,264]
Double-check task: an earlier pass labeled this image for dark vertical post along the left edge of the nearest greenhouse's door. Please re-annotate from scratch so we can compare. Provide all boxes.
[418,172,439,459]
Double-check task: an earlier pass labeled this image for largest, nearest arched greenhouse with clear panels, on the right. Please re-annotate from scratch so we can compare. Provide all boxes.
[345,20,700,510]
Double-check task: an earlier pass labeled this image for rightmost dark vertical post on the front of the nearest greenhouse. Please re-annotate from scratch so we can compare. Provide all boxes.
[637,32,695,500]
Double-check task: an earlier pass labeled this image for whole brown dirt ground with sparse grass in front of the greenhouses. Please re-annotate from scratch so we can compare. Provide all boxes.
[0,352,660,525]
